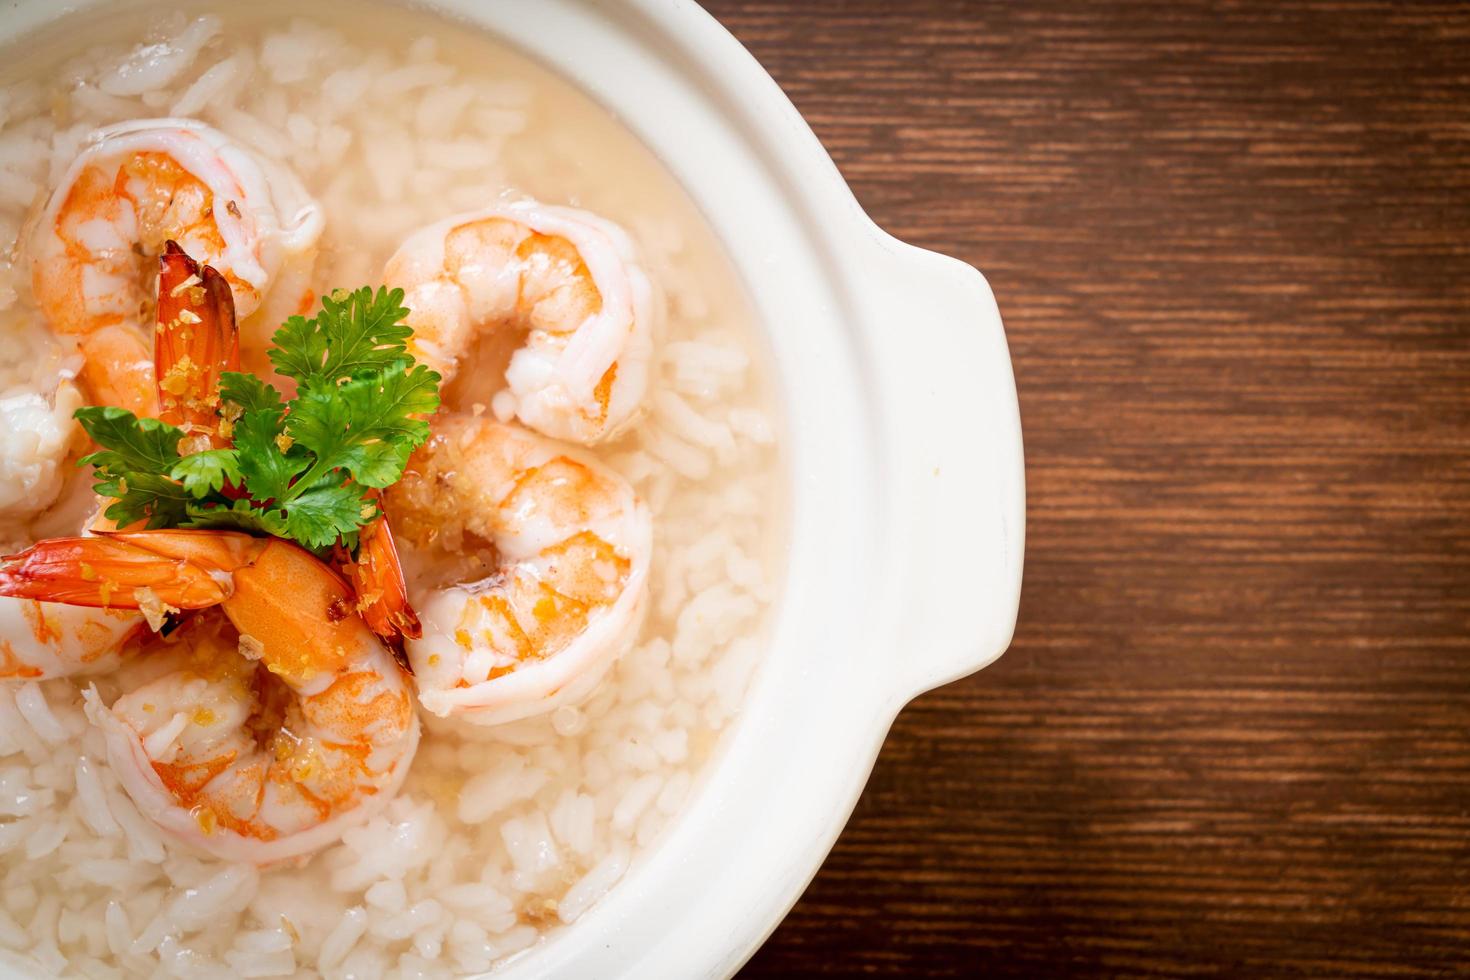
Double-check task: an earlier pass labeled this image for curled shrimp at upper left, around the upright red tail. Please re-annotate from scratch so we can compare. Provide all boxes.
[29,119,322,416]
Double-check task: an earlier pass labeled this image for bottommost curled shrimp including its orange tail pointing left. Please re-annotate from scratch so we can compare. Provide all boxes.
[0,530,419,864]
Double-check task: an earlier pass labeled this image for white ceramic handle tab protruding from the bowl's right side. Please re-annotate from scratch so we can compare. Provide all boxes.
[857,234,1026,701]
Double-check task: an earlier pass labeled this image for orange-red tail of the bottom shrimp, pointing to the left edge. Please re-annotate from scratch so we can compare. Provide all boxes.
[0,532,229,610]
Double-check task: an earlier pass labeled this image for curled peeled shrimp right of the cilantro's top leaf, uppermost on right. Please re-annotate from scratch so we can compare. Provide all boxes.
[384,201,662,445]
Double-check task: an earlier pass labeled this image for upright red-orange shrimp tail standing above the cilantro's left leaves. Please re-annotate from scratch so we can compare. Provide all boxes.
[153,241,240,448]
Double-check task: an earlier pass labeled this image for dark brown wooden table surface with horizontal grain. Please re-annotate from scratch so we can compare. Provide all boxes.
[707,0,1470,977]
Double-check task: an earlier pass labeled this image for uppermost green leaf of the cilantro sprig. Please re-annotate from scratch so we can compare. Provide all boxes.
[270,287,413,383]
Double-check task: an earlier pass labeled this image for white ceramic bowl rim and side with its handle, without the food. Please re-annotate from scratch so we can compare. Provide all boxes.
[0,0,1025,980]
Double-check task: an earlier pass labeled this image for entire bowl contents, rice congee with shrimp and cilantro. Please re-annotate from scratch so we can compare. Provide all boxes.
[0,0,784,977]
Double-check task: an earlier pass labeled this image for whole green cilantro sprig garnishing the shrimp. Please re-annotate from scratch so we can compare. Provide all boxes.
[76,287,440,552]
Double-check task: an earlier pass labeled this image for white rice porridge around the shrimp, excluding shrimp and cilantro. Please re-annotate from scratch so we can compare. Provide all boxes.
[0,0,782,977]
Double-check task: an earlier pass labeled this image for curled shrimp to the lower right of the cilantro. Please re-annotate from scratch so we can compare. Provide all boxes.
[385,414,653,724]
